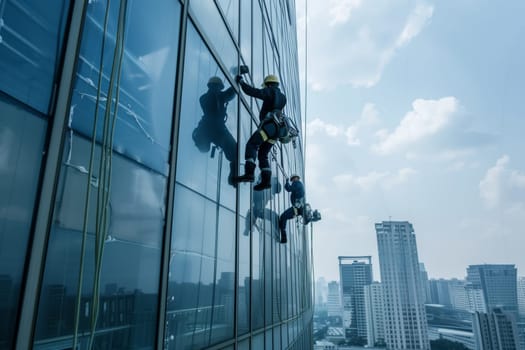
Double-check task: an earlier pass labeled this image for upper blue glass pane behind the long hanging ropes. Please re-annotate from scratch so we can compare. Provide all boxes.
[69,0,180,175]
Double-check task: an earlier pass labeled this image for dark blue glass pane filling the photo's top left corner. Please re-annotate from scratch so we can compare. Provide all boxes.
[0,0,70,114]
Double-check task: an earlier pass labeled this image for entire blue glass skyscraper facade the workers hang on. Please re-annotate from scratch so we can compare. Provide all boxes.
[0,0,313,349]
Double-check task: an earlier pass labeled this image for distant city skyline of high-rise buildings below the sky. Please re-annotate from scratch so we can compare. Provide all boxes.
[314,221,525,350]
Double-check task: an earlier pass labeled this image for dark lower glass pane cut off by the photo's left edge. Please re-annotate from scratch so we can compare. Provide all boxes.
[0,96,47,349]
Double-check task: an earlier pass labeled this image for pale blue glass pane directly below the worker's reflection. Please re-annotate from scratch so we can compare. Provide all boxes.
[166,185,235,349]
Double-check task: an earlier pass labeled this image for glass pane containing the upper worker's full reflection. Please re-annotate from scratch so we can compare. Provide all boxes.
[177,25,238,209]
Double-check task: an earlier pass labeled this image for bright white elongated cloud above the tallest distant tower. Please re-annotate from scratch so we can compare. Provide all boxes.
[373,97,459,154]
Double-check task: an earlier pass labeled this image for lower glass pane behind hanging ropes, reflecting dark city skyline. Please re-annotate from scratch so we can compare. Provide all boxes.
[35,134,166,348]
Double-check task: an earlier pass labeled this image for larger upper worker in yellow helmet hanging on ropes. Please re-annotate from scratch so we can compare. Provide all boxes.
[235,74,286,191]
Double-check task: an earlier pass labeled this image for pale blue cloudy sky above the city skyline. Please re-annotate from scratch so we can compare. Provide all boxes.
[296,0,525,281]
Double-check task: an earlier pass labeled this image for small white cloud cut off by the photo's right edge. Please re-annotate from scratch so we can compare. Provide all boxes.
[479,155,525,209]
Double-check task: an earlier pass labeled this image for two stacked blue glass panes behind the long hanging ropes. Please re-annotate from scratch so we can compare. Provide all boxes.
[34,0,180,349]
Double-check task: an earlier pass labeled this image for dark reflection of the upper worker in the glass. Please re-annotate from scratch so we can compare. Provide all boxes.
[192,77,238,185]
